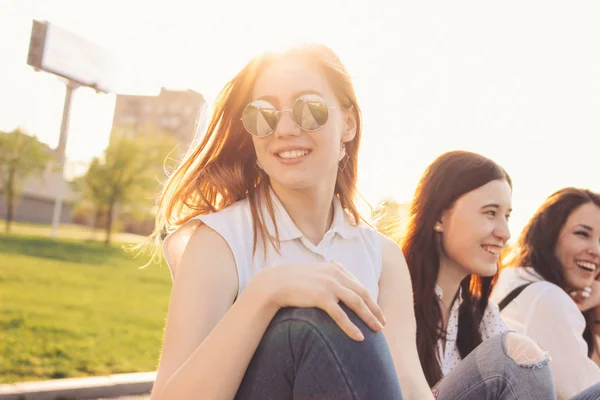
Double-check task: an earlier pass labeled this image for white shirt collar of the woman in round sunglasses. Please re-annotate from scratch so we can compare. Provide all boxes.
[262,190,358,242]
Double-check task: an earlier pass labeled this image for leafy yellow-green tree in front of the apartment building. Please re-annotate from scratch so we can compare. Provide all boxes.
[75,133,176,245]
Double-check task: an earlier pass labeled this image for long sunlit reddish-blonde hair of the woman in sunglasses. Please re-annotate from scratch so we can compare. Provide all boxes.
[145,45,361,261]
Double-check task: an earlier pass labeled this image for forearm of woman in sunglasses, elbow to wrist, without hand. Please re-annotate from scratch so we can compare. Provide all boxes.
[151,288,277,400]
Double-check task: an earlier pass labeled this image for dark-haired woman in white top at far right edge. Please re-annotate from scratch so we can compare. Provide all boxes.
[492,188,600,400]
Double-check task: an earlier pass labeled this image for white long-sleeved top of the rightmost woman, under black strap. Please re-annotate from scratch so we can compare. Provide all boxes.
[492,268,600,400]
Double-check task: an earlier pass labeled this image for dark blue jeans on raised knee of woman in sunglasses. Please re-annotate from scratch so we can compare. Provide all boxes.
[235,305,402,400]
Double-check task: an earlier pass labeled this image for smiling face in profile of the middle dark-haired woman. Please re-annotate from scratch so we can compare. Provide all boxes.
[440,179,512,276]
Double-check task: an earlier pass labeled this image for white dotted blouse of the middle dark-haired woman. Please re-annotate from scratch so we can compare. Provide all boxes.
[435,285,508,376]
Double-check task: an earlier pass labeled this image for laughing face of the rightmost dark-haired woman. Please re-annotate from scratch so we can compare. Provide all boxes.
[554,203,600,290]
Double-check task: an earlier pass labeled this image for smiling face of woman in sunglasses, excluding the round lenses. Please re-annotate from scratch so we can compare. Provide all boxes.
[252,58,356,189]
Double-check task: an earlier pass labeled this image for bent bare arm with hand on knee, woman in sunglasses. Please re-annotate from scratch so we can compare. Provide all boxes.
[151,225,383,400]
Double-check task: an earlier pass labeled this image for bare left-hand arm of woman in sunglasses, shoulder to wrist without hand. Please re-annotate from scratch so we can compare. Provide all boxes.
[151,225,277,400]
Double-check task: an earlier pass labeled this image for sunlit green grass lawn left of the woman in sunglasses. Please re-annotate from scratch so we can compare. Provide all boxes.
[0,232,171,383]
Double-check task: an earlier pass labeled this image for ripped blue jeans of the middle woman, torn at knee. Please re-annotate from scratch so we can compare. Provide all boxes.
[435,333,556,400]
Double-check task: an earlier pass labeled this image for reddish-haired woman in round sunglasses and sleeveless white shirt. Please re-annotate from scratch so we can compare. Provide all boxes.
[151,46,432,400]
